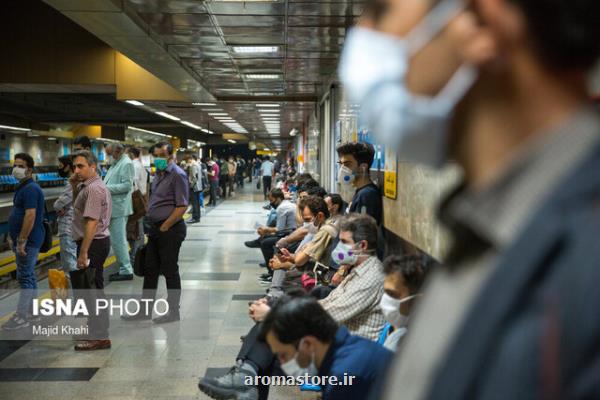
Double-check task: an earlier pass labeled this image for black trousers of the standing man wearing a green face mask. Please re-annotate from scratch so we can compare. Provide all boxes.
[142,220,186,311]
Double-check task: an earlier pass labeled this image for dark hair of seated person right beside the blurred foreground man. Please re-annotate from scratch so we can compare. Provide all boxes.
[383,254,438,294]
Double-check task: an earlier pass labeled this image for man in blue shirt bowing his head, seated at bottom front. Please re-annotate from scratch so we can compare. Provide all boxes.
[260,298,392,400]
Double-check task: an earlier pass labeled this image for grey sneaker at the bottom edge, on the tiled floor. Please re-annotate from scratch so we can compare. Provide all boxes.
[198,365,258,400]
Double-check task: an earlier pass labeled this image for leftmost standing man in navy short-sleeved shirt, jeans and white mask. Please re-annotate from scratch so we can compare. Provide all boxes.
[2,153,45,331]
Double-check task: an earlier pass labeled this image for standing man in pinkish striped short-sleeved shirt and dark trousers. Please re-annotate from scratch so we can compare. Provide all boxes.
[69,150,112,351]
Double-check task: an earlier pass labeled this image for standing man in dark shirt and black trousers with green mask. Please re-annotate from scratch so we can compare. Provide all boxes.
[121,142,190,324]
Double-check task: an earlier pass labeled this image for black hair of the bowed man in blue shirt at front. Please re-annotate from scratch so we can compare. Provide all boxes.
[258,296,338,345]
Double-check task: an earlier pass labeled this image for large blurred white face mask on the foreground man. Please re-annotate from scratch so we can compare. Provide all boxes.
[339,0,477,168]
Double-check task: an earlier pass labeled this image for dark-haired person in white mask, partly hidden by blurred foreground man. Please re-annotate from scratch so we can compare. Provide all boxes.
[380,255,435,351]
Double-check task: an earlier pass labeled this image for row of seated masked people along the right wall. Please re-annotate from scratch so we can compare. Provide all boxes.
[199,183,434,399]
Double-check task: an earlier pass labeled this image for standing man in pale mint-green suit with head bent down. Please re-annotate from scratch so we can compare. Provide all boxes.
[104,143,135,281]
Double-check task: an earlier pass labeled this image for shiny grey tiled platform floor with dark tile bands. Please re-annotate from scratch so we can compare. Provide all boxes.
[0,185,300,400]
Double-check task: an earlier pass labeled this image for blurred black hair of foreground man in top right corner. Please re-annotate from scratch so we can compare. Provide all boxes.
[512,0,600,70]
